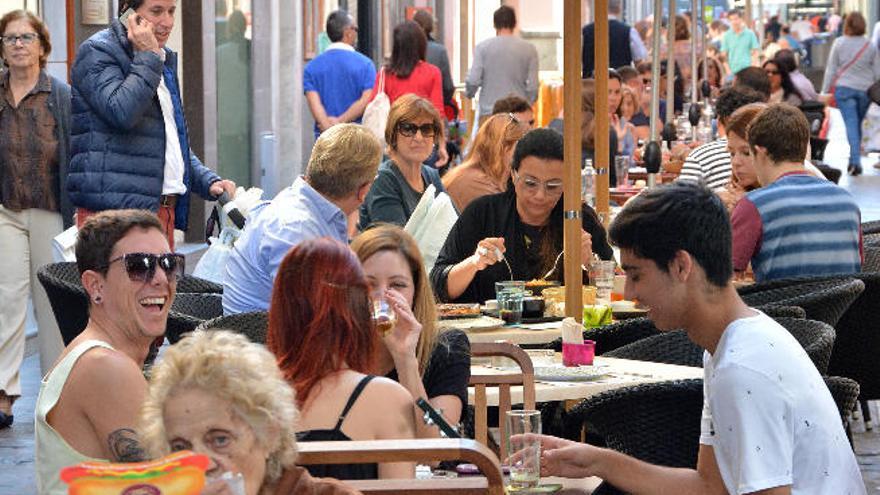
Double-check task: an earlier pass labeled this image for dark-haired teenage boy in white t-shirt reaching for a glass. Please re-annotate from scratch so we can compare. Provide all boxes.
[524,183,865,495]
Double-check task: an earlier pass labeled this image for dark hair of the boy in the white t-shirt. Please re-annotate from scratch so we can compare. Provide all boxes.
[609,182,733,287]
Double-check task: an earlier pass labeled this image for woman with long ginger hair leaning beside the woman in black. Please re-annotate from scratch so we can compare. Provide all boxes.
[443,113,529,211]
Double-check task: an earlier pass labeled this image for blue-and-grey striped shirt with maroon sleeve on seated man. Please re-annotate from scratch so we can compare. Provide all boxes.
[730,172,861,282]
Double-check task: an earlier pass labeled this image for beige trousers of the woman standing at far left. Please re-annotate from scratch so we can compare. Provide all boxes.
[0,205,64,396]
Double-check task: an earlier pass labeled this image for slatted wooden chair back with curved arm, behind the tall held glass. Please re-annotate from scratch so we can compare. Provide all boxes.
[468,342,535,456]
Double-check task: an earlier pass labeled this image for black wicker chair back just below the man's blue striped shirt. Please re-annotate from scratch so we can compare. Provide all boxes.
[739,277,865,327]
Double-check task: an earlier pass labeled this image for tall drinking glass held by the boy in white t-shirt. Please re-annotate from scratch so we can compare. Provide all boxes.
[507,410,541,492]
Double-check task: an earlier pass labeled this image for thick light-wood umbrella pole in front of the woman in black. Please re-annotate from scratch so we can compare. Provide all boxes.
[562,0,584,321]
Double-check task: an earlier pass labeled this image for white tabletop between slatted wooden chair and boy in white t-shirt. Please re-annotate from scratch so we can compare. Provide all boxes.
[468,353,703,406]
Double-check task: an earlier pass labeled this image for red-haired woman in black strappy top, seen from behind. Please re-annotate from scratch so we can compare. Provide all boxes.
[266,238,415,479]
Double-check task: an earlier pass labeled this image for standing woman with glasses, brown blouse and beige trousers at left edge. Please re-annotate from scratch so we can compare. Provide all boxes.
[0,10,73,429]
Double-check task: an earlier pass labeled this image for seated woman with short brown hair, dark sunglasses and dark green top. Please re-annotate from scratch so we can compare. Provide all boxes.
[358,94,444,230]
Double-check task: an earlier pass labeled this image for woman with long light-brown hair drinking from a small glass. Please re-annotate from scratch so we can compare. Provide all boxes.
[351,224,471,438]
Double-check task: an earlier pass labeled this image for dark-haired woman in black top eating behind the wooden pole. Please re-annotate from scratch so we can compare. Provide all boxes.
[431,129,612,302]
